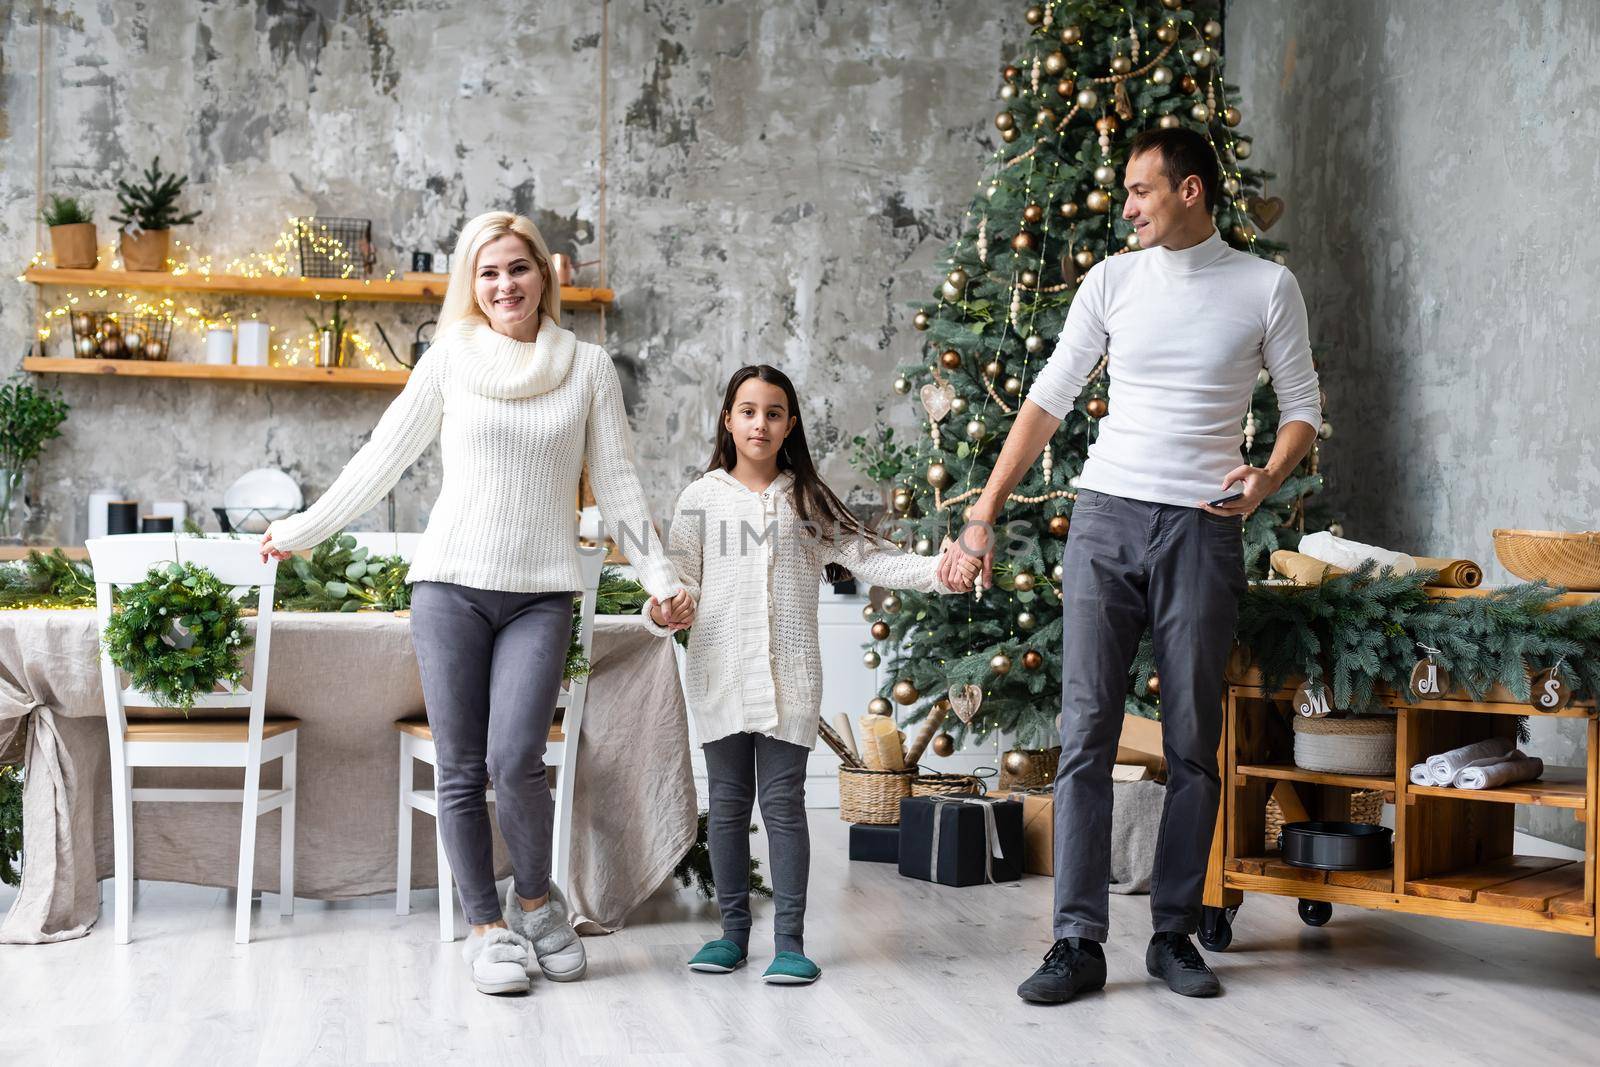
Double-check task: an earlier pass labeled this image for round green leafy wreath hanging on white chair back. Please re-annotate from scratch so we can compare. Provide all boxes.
[104,563,253,713]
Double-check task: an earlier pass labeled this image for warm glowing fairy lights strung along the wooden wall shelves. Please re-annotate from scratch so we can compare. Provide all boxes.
[18,216,409,370]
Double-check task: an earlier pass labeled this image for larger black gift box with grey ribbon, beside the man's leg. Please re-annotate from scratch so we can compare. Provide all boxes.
[899,795,1022,886]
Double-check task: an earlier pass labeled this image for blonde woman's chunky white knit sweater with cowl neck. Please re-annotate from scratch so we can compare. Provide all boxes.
[272,320,682,600]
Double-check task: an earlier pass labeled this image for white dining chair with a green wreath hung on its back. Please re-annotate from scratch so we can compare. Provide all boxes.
[86,534,299,944]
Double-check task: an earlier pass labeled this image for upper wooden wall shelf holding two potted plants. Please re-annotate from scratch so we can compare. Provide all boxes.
[22,267,616,310]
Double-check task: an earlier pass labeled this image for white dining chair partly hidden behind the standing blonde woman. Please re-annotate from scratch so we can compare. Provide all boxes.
[395,547,605,941]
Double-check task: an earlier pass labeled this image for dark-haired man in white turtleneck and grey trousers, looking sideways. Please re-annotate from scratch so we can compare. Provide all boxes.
[941,130,1322,1003]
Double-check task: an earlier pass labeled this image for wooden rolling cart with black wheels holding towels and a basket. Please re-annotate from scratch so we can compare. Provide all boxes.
[1200,617,1600,957]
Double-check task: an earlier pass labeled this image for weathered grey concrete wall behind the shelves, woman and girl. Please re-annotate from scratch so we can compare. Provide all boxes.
[0,0,1021,541]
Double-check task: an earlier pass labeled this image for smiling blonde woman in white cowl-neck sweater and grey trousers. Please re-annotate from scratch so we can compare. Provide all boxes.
[261,211,693,993]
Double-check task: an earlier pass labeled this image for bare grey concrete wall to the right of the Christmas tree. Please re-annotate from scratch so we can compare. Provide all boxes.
[1227,0,1600,845]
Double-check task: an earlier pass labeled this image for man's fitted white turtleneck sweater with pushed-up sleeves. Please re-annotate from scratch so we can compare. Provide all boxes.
[1027,230,1322,507]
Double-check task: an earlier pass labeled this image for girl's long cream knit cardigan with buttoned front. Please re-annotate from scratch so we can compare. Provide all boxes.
[645,470,950,749]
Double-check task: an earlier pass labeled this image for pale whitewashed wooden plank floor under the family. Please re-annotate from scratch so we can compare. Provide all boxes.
[0,811,1600,1067]
